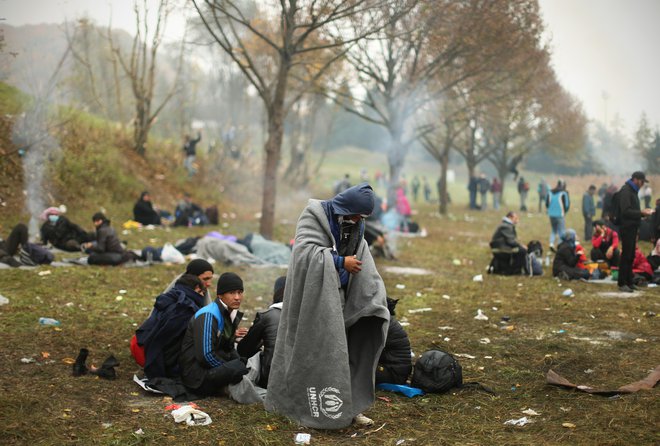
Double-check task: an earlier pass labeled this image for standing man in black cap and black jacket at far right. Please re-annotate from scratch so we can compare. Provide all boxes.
[614,171,653,293]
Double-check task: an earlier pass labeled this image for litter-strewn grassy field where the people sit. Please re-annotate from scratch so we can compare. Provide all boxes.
[0,179,660,445]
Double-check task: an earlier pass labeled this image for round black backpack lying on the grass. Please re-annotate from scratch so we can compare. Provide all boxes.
[411,350,463,393]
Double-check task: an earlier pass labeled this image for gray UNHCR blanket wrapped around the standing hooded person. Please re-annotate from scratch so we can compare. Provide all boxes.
[265,200,389,429]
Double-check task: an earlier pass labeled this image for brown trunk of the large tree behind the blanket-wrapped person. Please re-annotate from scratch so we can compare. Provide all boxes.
[259,62,289,239]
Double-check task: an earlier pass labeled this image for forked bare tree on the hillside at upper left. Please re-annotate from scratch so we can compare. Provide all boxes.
[108,0,185,156]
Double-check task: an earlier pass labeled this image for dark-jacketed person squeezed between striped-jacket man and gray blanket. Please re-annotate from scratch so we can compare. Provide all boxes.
[237,276,286,389]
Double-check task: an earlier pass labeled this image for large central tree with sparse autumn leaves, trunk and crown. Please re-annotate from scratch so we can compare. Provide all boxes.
[193,0,398,237]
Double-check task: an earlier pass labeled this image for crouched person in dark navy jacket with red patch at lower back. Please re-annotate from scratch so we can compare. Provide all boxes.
[131,274,206,379]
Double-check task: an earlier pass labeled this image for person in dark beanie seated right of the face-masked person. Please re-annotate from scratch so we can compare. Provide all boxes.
[82,212,137,266]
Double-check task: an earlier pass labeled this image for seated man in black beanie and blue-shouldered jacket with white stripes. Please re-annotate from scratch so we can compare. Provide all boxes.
[179,273,248,396]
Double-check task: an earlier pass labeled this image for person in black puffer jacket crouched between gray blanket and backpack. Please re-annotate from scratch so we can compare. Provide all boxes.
[376,297,412,384]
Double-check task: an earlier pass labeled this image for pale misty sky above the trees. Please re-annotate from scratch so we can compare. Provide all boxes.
[0,0,660,132]
